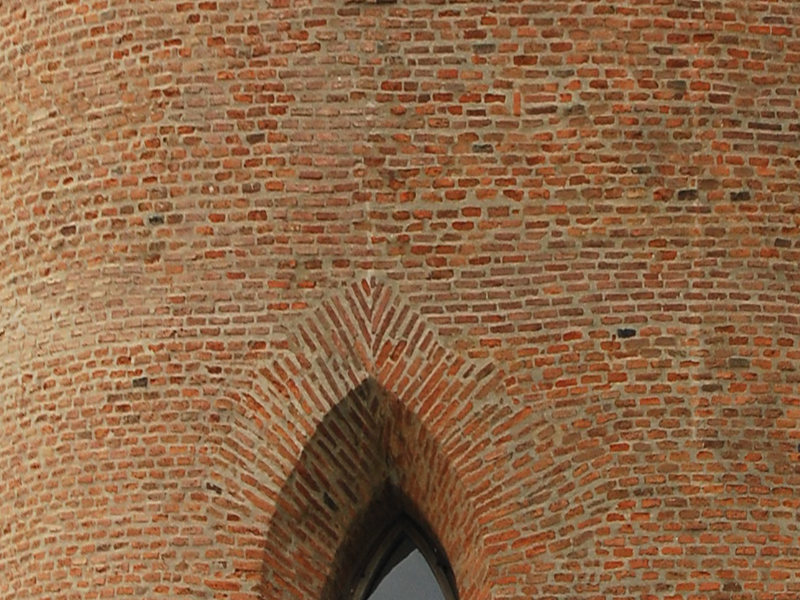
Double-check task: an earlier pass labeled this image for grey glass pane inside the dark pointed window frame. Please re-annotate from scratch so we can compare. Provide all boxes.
[367,536,445,600]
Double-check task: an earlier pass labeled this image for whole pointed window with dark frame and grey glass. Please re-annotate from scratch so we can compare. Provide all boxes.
[353,519,457,600]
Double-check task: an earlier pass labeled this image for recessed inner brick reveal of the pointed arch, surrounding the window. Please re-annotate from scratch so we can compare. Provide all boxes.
[259,378,485,600]
